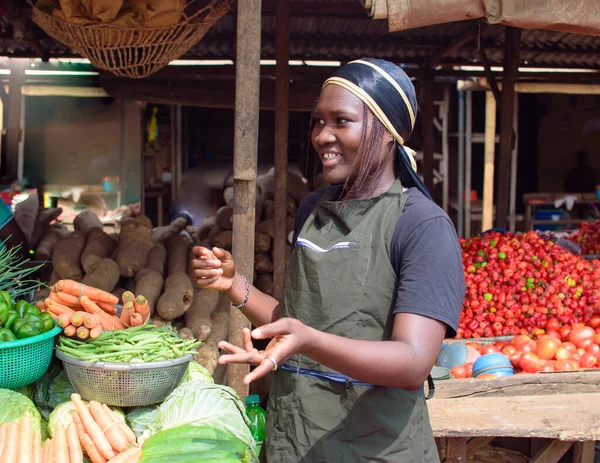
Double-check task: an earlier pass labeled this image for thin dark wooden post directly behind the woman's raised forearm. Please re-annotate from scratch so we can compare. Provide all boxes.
[273,0,290,299]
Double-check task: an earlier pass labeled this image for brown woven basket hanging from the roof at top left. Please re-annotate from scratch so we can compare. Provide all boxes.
[33,0,230,79]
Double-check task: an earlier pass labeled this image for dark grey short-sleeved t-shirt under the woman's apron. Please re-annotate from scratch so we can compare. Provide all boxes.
[292,188,466,338]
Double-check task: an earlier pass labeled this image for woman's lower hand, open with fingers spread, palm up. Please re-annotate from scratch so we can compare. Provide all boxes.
[219,318,309,384]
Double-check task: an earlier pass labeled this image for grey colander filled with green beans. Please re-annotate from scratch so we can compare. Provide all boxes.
[56,350,193,407]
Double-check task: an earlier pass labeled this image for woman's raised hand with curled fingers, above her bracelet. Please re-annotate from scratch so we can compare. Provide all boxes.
[192,246,235,293]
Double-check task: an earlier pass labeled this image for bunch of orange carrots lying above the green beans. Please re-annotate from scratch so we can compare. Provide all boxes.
[38,280,150,339]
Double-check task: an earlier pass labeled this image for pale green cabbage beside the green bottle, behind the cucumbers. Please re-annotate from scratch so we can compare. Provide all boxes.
[142,381,256,461]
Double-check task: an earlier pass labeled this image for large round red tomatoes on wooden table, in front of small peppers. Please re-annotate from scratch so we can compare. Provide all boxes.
[451,326,600,379]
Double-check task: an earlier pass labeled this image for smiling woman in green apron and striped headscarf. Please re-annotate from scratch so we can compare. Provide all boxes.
[193,59,465,462]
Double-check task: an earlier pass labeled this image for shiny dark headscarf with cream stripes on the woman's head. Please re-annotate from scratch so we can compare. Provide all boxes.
[323,58,431,199]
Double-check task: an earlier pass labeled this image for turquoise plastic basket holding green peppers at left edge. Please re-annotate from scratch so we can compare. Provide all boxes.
[0,326,62,389]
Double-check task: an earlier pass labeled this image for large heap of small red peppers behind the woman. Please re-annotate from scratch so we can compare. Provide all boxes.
[457,232,600,338]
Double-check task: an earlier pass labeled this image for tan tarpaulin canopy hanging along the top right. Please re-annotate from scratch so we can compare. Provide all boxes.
[363,0,600,35]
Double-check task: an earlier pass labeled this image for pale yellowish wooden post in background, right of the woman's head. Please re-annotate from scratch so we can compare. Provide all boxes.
[481,92,496,231]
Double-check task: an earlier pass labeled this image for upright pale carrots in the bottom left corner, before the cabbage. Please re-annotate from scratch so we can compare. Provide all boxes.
[0,413,41,463]
